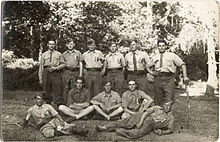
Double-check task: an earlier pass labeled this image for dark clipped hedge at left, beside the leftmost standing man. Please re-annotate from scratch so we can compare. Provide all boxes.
[3,65,41,91]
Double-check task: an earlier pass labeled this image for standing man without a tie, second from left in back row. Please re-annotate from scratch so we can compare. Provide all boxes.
[62,40,83,104]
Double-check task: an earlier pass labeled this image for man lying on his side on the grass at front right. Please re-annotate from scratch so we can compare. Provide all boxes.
[96,102,174,139]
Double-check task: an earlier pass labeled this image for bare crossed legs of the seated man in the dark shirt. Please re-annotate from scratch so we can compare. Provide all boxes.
[59,105,94,119]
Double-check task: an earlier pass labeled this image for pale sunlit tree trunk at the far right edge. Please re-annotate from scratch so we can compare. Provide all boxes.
[205,36,217,96]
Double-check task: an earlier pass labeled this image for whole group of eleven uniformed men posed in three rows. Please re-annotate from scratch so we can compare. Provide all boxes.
[25,39,189,138]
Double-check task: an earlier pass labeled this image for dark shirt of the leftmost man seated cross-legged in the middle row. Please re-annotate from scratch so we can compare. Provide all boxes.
[67,88,90,106]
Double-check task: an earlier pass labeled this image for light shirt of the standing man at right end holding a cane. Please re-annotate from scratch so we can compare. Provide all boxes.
[152,52,184,73]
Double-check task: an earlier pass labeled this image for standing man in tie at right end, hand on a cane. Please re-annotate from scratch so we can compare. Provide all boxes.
[152,40,189,106]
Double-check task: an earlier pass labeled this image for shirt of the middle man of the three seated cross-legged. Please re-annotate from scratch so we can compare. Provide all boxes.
[92,91,121,108]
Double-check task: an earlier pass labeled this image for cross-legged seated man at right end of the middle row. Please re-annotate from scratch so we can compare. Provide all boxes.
[122,80,153,119]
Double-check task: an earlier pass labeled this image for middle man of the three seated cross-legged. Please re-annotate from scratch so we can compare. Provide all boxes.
[91,81,123,120]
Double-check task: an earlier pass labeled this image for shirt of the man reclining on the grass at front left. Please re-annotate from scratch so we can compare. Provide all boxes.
[28,104,58,125]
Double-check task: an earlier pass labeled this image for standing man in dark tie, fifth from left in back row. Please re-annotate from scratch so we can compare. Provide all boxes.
[125,40,152,95]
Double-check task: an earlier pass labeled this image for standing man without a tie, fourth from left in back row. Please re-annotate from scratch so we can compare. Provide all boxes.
[102,43,126,95]
